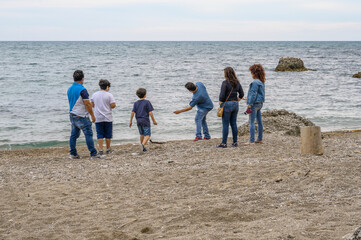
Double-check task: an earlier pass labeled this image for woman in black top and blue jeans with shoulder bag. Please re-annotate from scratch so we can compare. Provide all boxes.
[217,67,244,148]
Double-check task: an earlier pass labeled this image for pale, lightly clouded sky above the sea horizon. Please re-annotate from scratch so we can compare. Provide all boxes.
[0,0,361,41]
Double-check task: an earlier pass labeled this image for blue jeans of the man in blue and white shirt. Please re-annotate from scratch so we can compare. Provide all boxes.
[70,114,97,156]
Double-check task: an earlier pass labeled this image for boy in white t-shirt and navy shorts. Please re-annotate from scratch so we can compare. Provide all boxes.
[91,79,116,154]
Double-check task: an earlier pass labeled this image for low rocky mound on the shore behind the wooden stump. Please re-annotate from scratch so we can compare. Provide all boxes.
[238,109,315,136]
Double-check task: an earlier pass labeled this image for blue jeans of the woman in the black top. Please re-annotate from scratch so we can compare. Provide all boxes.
[222,101,239,144]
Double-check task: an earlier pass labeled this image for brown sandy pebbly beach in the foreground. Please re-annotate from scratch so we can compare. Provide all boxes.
[0,132,361,240]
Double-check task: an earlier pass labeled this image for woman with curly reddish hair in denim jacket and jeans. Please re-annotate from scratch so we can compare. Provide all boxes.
[244,64,266,145]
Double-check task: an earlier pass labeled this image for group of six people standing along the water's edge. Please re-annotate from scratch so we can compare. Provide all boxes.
[68,64,266,159]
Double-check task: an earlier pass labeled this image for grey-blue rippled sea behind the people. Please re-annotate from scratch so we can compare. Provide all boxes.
[0,42,361,150]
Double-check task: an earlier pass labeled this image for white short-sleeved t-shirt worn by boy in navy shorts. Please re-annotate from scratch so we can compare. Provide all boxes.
[91,91,115,123]
